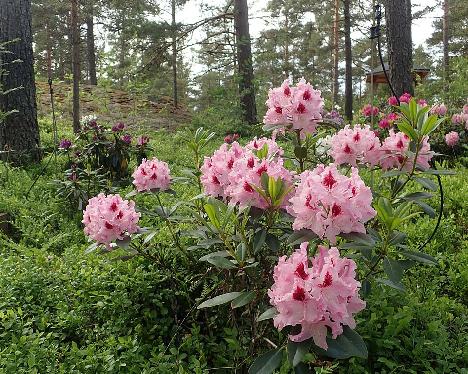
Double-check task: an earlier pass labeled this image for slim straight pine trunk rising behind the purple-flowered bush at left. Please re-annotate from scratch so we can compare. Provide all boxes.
[71,0,81,133]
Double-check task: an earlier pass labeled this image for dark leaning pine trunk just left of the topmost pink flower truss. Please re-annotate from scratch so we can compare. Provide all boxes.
[234,0,257,124]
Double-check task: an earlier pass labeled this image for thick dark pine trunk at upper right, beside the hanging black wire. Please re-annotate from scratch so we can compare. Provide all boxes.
[385,0,414,96]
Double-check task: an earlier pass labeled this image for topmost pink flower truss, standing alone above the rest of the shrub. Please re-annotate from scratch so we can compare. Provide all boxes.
[263,79,324,133]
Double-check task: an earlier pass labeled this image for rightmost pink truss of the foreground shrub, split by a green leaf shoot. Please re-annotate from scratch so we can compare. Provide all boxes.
[380,129,434,171]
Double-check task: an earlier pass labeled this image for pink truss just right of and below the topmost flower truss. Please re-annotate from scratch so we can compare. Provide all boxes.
[330,125,381,166]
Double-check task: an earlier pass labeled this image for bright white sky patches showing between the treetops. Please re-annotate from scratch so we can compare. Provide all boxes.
[173,0,442,76]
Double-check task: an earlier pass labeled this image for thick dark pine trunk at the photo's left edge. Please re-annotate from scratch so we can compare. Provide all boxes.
[0,0,41,163]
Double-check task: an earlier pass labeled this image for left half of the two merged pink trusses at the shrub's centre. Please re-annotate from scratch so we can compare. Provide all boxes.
[200,142,245,198]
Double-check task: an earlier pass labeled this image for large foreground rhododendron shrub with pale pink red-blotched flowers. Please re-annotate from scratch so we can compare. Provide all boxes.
[83,90,447,373]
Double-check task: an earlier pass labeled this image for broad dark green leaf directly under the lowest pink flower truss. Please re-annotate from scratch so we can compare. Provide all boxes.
[318,326,367,359]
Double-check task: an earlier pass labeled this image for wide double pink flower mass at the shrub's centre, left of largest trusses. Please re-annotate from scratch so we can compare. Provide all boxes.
[200,138,293,209]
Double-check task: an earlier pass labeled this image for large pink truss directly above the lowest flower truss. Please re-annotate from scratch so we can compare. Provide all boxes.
[288,164,376,244]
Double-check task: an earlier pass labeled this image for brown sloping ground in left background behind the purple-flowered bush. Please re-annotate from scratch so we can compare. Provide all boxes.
[36,81,191,131]
